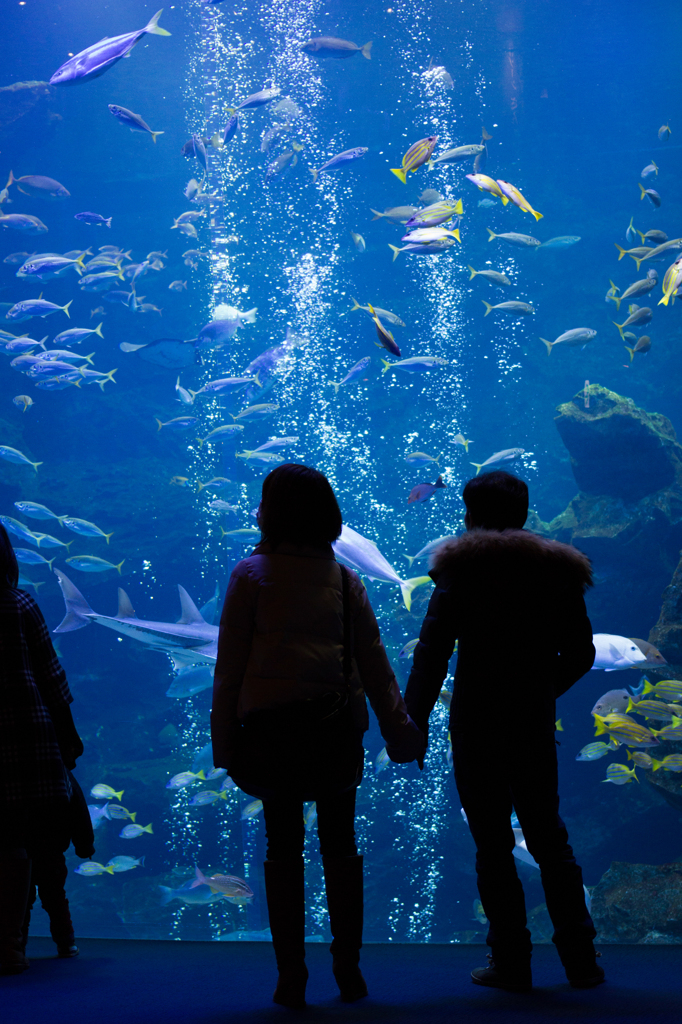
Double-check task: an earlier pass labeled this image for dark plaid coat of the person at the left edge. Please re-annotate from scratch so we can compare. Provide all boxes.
[0,588,73,805]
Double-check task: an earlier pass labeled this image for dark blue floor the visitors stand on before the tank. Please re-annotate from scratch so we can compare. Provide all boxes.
[0,939,682,1024]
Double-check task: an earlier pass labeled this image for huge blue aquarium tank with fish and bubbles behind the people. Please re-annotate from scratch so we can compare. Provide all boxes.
[0,0,682,942]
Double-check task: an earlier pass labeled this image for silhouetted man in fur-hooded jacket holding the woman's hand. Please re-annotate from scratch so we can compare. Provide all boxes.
[406,471,604,991]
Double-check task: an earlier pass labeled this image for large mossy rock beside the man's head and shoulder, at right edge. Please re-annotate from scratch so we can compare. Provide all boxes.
[528,384,682,634]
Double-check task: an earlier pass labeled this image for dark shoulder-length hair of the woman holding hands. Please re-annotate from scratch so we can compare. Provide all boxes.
[258,462,343,547]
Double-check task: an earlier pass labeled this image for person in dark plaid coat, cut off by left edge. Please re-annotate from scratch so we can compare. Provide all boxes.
[0,524,83,974]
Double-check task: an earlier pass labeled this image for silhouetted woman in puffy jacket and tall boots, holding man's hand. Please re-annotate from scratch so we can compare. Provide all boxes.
[211,464,423,1006]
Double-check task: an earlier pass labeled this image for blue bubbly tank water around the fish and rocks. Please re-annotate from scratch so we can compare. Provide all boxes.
[0,0,682,942]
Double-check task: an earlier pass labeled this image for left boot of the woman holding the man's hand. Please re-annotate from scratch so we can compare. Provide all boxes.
[263,857,308,1009]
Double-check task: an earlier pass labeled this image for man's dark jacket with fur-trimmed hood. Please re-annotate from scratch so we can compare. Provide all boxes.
[406,529,595,737]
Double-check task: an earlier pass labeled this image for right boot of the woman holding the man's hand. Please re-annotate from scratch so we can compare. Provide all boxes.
[323,856,368,1002]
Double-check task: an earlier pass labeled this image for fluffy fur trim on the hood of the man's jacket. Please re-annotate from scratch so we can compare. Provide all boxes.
[429,529,593,592]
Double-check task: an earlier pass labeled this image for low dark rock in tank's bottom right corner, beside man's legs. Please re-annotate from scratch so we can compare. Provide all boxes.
[592,861,682,944]
